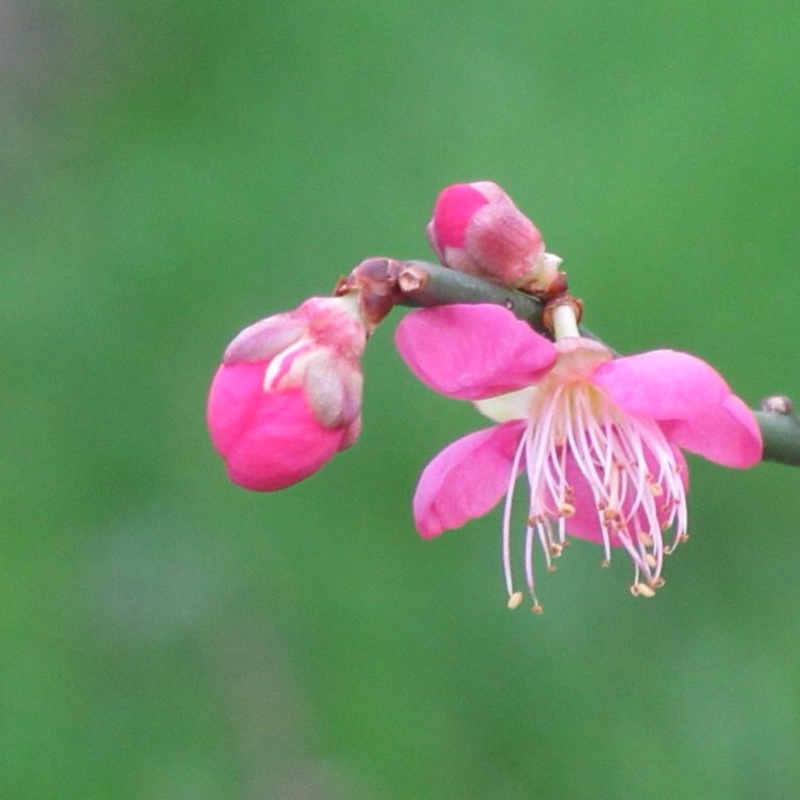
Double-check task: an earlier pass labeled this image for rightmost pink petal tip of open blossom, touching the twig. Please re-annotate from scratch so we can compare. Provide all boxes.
[661,394,763,468]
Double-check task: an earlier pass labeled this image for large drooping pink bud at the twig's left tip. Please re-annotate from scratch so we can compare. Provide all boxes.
[207,294,367,492]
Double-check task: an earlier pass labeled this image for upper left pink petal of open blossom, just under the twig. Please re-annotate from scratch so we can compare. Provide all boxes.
[395,304,556,400]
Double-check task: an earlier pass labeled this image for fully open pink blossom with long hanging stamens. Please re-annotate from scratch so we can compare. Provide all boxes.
[397,305,762,611]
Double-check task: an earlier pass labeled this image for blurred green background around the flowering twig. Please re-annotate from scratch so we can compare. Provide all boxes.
[0,0,800,800]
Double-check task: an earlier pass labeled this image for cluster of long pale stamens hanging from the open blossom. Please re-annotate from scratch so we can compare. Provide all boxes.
[494,350,687,613]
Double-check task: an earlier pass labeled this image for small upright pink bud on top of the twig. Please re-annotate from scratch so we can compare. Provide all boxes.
[426,181,561,291]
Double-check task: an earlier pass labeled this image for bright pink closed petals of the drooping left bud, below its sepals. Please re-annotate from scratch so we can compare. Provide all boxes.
[208,364,346,492]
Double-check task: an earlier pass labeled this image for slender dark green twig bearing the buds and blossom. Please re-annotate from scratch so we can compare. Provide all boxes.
[394,261,800,466]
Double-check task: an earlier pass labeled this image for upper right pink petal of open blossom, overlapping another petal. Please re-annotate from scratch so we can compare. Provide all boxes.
[592,350,731,420]
